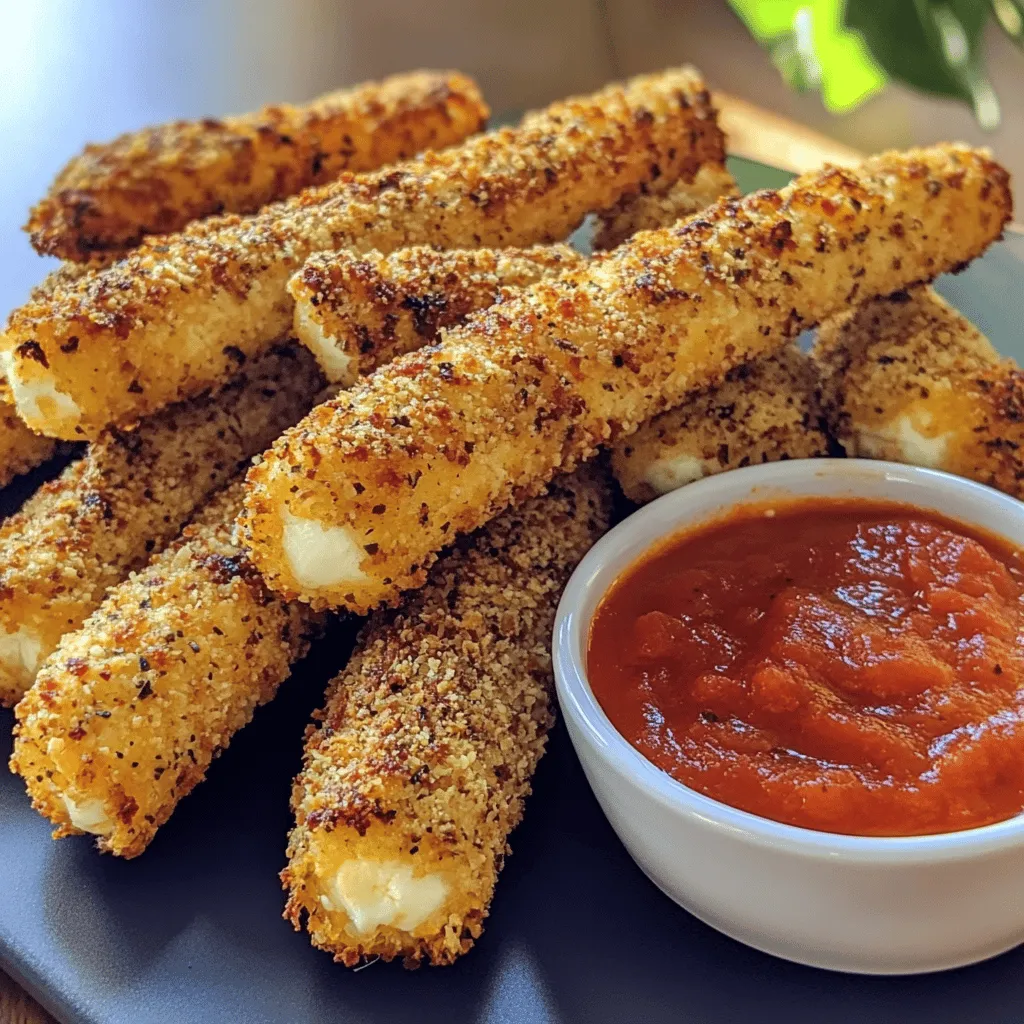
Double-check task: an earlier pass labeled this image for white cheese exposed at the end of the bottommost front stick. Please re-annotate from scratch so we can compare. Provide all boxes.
[321,860,449,935]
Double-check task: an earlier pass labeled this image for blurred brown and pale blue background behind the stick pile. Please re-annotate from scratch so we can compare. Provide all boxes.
[0,0,1024,309]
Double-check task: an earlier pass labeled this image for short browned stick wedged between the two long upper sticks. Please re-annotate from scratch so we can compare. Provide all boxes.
[288,245,584,387]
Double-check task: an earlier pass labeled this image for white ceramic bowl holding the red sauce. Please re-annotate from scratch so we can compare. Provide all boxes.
[554,459,1024,974]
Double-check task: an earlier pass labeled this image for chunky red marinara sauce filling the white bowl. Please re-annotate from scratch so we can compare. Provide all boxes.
[587,499,1024,836]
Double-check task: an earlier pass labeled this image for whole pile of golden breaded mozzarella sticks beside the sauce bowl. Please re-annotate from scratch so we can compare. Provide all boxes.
[0,69,1011,966]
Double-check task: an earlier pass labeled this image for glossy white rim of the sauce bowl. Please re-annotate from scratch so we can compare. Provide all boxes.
[552,458,1024,863]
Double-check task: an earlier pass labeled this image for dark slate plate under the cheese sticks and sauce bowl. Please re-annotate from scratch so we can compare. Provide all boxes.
[0,159,1024,1024]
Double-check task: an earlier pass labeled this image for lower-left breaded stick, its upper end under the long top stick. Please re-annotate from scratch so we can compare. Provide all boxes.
[11,478,323,857]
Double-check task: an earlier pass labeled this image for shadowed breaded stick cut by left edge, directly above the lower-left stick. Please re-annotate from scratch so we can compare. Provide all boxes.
[0,347,319,705]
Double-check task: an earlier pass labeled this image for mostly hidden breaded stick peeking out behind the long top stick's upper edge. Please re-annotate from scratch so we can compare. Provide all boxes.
[593,162,739,249]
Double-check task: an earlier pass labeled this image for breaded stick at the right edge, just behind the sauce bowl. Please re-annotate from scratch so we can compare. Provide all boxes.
[813,288,1024,498]
